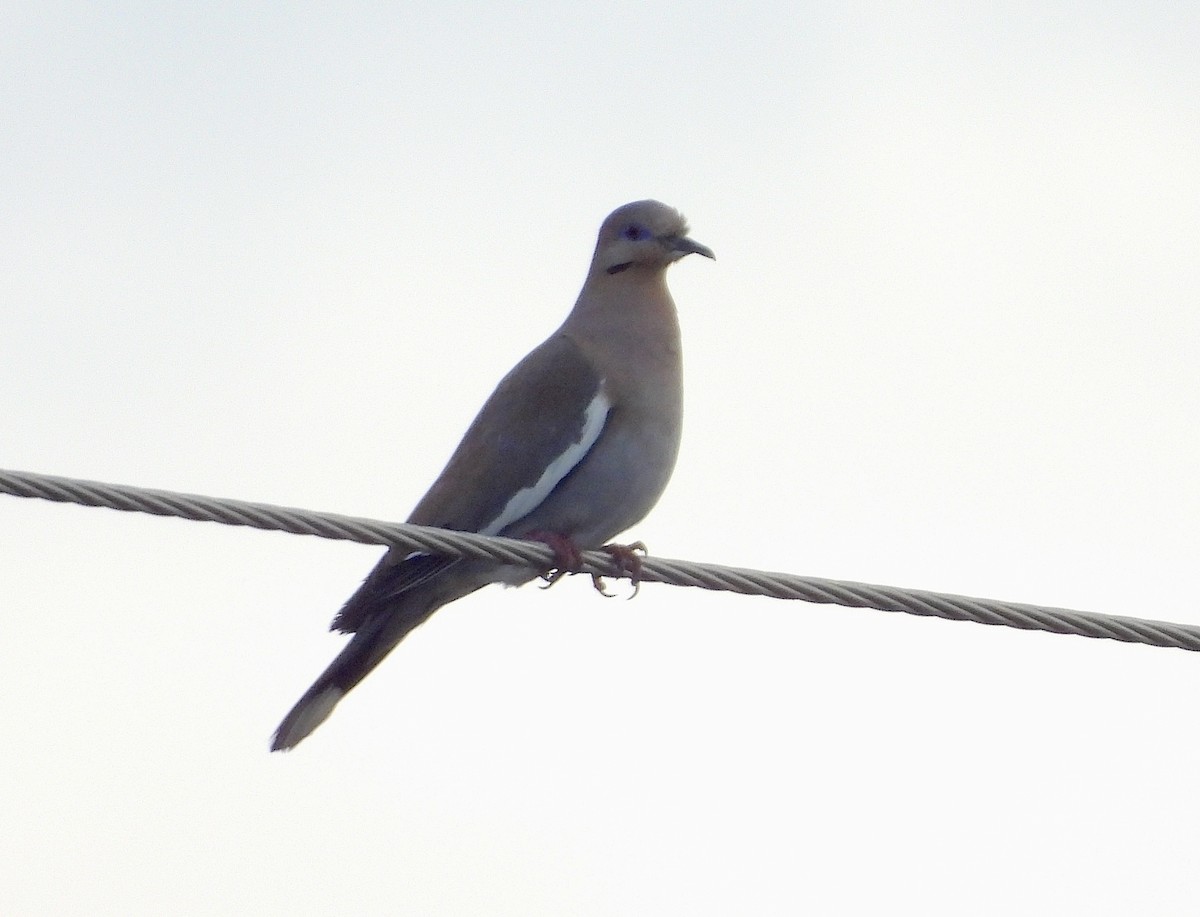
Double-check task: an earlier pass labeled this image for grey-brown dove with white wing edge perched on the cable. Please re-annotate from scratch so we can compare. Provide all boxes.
[271,200,715,751]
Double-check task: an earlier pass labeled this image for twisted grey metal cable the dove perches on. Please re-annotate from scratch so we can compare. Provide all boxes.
[0,471,1200,652]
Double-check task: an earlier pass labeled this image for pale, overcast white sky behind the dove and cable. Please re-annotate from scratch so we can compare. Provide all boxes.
[0,2,1200,917]
